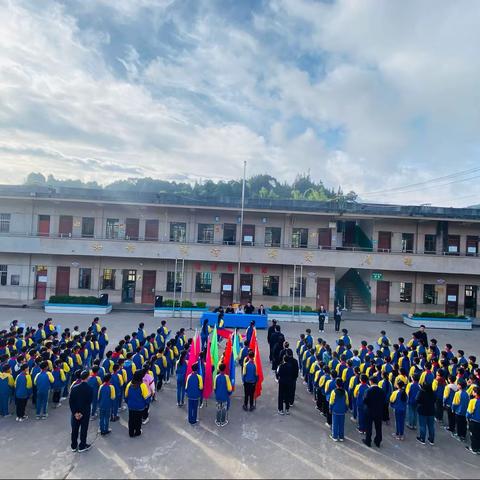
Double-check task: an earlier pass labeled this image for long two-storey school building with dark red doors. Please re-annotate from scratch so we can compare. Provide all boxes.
[0,186,480,316]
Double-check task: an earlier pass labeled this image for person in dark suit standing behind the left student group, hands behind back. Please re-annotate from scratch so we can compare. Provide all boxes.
[69,370,93,452]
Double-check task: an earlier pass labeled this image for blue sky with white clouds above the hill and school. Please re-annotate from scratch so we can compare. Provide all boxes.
[0,0,480,206]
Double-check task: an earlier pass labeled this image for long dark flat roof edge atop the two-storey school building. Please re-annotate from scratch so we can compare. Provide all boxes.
[0,185,480,222]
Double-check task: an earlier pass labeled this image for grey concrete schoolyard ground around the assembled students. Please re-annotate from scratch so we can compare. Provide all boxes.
[0,308,480,478]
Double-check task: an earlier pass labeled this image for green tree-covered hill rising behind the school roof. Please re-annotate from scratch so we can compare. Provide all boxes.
[24,173,357,201]
